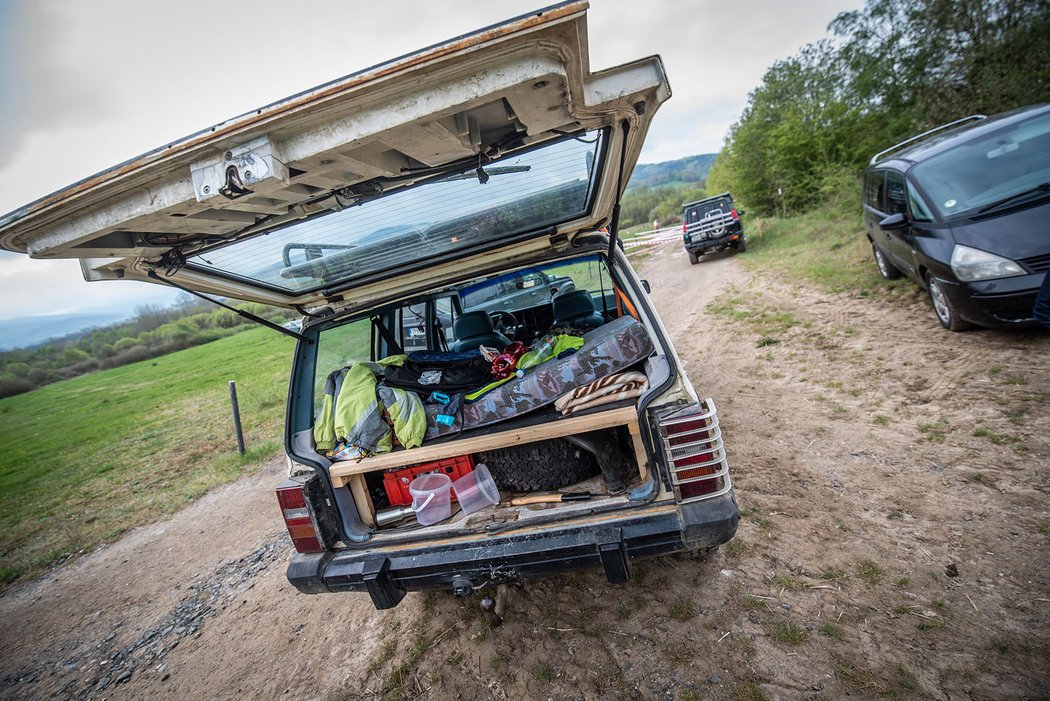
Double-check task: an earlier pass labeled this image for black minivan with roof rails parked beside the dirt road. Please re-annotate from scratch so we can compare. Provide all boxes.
[863,104,1050,331]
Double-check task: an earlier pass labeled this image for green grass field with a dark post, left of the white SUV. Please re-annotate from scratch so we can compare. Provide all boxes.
[0,328,294,583]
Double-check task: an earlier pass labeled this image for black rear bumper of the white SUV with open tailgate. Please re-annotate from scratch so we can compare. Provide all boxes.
[288,491,740,609]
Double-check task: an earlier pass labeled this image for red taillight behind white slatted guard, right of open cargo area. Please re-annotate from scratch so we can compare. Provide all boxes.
[659,399,731,501]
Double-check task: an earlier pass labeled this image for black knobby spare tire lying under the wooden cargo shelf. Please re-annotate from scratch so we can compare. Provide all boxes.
[475,439,602,492]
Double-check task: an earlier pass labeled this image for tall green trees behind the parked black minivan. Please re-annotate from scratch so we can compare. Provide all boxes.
[708,0,1050,214]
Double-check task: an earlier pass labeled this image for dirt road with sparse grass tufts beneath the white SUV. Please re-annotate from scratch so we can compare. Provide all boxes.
[0,246,1050,701]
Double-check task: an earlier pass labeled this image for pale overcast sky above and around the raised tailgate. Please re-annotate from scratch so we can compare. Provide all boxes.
[0,0,863,329]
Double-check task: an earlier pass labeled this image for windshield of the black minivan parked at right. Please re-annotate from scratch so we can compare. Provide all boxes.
[911,113,1050,217]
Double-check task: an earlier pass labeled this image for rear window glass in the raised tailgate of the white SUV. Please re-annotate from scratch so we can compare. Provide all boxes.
[187,132,603,293]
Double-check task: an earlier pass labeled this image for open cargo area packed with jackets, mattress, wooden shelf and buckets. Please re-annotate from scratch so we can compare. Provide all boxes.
[300,256,655,537]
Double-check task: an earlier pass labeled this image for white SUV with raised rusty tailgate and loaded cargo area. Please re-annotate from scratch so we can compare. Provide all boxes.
[0,2,738,608]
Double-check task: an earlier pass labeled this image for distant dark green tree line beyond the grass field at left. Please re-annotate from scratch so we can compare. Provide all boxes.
[0,295,295,398]
